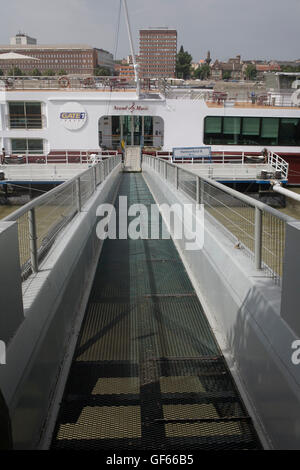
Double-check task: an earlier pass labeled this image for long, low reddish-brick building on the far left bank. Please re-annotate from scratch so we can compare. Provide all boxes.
[0,35,114,75]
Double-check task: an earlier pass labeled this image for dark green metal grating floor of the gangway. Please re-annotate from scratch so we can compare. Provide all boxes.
[52,173,261,451]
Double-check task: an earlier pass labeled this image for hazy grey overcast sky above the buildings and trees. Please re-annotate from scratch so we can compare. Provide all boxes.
[0,0,300,61]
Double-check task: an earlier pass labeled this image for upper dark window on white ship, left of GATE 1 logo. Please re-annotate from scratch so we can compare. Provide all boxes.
[9,101,42,129]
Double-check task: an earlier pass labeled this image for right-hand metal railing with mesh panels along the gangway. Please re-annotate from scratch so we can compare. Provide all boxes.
[143,155,296,284]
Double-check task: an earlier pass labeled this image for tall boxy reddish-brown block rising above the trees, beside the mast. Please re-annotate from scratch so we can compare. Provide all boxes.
[139,28,177,78]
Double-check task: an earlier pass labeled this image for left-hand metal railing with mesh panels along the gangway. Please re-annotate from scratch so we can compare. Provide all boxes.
[2,155,121,280]
